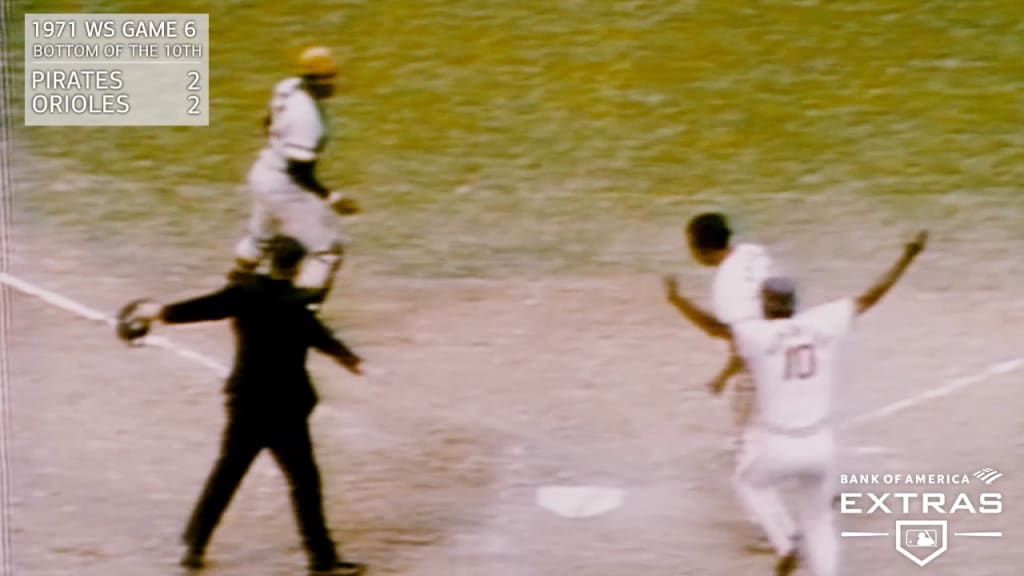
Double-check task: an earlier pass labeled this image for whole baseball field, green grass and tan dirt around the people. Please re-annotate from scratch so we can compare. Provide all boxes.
[3,0,1024,576]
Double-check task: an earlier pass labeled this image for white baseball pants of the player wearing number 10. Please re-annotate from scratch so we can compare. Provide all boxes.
[733,424,839,576]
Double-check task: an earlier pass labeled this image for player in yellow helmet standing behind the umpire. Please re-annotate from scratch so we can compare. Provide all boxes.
[234,46,358,305]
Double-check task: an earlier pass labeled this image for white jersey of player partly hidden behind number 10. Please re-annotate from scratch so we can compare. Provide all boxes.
[712,244,772,326]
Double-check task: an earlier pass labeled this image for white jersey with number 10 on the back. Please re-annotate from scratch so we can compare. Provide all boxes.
[732,298,856,430]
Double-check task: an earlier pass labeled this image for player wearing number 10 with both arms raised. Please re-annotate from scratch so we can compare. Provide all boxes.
[666,232,928,576]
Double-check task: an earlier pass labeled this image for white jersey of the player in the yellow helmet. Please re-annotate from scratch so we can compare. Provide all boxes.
[257,78,328,170]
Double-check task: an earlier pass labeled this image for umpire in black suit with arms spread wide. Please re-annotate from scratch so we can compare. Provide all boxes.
[119,237,365,576]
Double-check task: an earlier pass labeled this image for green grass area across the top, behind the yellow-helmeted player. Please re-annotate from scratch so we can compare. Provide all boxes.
[11,0,1024,276]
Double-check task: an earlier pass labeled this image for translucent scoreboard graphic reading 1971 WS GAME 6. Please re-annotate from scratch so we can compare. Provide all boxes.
[25,13,210,126]
